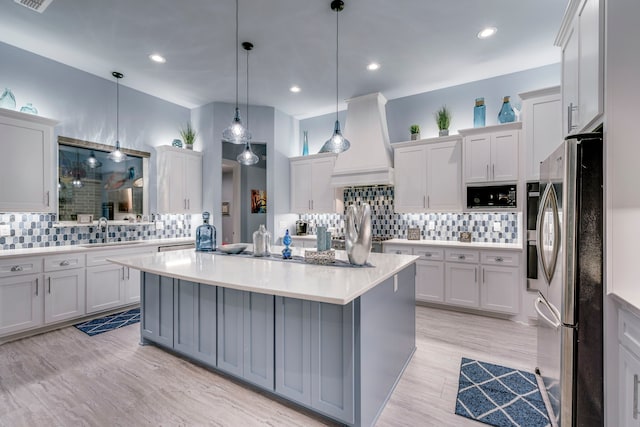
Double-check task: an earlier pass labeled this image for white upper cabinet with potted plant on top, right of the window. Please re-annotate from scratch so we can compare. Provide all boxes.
[156,145,203,213]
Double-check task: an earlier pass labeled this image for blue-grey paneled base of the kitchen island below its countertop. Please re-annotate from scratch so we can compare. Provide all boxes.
[140,264,415,426]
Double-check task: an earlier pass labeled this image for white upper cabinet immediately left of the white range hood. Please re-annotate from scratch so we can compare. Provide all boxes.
[289,153,343,213]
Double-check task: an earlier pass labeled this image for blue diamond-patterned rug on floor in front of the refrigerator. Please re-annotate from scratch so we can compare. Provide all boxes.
[456,357,550,427]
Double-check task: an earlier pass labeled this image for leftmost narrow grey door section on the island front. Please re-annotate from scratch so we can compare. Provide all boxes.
[140,273,174,348]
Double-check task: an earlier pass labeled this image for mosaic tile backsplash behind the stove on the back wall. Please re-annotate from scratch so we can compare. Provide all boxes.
[300,186,522,243]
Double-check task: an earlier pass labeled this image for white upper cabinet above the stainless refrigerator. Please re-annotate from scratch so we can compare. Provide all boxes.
[556,0,604,135]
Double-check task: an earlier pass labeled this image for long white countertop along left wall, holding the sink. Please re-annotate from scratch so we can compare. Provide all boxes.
[0,237,195,259]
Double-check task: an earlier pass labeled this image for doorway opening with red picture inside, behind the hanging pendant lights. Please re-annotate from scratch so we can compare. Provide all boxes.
[218,142,269,244]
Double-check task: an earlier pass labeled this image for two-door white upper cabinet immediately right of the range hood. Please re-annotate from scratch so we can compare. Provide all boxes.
[393,135,462,213]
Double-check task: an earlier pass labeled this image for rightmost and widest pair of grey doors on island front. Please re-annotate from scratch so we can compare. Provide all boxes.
[275,297,355,423]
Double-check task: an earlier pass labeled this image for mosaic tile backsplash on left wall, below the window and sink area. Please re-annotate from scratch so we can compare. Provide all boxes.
[0,213,191,250]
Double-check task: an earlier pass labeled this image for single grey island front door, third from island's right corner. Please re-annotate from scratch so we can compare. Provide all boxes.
[241,292,274,390]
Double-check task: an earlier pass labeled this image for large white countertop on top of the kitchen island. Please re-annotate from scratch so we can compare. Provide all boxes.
[108,246,418,305]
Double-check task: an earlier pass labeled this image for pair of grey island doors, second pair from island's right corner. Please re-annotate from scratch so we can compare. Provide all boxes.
[217,287,274,389]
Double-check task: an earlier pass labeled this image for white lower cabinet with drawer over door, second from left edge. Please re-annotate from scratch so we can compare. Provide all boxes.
[44,253,85,323]
